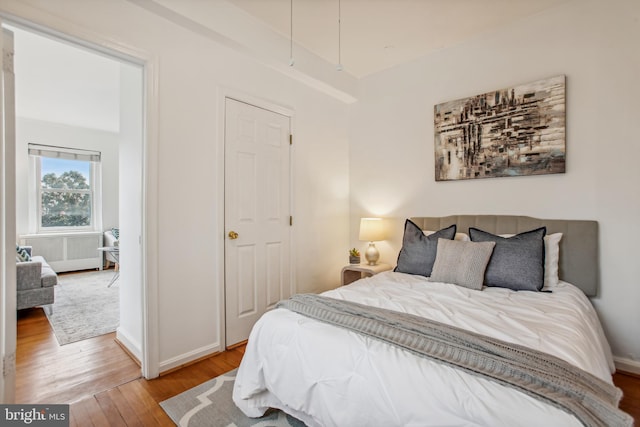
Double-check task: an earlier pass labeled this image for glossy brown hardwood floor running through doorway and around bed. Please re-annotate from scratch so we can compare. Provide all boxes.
[16,309,640,427]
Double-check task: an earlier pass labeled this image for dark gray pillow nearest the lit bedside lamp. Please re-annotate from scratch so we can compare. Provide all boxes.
[393,219,456,277]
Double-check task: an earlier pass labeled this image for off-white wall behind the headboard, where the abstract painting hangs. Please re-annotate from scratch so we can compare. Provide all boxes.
[349,0,640,366]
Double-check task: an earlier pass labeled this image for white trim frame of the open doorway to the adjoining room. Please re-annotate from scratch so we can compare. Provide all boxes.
[0,11,160,379]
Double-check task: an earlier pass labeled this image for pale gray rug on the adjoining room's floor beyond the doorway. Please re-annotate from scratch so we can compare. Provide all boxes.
[44,270,120,345]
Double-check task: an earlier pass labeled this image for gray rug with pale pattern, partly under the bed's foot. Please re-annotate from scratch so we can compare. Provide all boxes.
[160,369,305,427]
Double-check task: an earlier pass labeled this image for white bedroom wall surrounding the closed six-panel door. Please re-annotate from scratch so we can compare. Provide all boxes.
[0,0,349,370]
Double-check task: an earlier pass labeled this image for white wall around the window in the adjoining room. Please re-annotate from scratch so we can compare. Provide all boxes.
[16,118,119,236]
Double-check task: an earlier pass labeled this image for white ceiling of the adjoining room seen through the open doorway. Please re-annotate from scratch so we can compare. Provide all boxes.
[10,27,120,132]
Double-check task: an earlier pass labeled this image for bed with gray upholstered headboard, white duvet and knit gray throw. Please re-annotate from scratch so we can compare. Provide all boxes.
[233,215,632,426]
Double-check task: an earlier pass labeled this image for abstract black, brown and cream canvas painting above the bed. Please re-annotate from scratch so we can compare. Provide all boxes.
[434,76,565,181]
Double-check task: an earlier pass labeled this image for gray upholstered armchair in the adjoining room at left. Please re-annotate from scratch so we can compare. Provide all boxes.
[16,246,58,310]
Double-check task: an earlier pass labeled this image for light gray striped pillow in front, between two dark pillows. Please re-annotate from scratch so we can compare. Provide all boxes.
[429,239,496,291]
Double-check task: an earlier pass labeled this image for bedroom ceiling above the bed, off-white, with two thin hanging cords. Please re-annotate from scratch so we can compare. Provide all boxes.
[229,0,570,77]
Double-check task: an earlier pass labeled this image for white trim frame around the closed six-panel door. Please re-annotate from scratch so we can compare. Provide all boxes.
[214,86,297,351]
